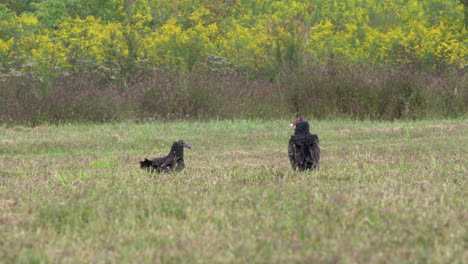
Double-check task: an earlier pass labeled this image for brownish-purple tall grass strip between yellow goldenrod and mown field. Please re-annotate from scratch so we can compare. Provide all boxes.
[0,62,468,124]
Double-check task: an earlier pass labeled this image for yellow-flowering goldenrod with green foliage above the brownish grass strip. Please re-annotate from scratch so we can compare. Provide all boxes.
[0,0,468,71]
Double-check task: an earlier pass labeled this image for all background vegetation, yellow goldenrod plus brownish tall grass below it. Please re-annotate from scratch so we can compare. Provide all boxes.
[0,0,468,123]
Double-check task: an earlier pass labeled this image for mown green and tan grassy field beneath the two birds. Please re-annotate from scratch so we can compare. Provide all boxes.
[0,120,468,263]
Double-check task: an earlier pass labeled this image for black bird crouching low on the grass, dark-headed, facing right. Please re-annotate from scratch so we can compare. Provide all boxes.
[140,140,191,172]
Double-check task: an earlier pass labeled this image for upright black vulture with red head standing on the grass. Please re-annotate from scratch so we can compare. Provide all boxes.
[288,118,320,171]
